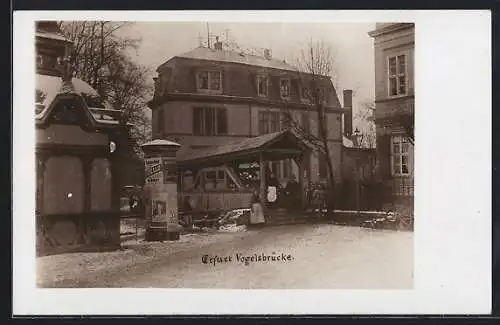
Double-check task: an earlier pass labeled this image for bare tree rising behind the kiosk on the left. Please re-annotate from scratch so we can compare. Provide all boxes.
[59,21,152,150]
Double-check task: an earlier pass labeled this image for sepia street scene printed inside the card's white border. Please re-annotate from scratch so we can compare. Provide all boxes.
[34,21,415,289]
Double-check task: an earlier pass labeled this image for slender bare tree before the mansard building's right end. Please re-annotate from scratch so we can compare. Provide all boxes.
[285,39,338,206]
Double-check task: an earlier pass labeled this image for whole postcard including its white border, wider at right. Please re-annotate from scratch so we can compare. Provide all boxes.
[12,10,491,315]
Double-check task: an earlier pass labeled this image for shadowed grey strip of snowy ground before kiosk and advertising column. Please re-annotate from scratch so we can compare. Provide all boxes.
[37,232,250,287]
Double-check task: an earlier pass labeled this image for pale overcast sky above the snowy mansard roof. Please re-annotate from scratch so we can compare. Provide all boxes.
[120,22,375,119]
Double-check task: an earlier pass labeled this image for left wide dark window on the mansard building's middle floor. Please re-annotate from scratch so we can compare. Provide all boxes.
[193,107,228,135]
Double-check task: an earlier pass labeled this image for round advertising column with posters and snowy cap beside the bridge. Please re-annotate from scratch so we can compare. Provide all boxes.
[142,140,181,241]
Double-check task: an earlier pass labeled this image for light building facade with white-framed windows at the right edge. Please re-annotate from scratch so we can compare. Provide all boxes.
[369,23,415,213]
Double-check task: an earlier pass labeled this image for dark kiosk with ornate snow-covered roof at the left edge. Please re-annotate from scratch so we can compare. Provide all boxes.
[35,22,127,255]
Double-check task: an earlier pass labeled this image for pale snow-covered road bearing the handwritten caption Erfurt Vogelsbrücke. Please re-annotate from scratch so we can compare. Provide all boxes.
[78,225,413,289]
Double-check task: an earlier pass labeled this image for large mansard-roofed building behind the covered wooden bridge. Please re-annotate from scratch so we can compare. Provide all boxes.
[150,43,352,189]
